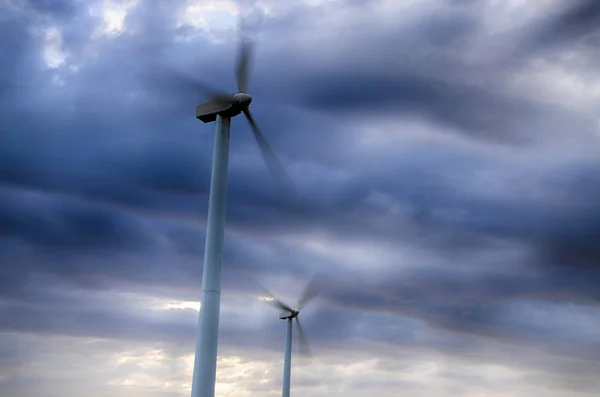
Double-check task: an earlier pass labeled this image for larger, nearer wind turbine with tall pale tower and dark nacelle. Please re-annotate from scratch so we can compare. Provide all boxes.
[162,19,295,397]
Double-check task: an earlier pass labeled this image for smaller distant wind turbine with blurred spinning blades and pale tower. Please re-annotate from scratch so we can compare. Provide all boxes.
[262,279,317,397]
